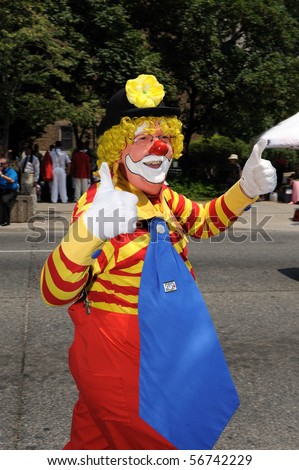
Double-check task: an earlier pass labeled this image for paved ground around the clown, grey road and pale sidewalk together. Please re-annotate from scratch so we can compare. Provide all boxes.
[0,202,299,450]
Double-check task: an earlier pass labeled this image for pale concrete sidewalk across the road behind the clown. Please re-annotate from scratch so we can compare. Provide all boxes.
[0,201,299,233]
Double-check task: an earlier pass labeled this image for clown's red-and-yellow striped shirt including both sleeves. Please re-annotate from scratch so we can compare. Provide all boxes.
[41,165,253,315]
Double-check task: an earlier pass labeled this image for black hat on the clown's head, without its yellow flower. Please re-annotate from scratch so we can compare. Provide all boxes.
[98,88,180,135]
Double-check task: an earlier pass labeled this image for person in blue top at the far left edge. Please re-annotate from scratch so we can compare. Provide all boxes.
[0,156,19,227]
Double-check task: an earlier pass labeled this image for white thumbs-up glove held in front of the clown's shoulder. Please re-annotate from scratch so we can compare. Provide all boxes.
[84,162,138,240]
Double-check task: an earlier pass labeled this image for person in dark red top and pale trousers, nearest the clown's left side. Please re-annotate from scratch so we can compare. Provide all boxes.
[70,142,90,202]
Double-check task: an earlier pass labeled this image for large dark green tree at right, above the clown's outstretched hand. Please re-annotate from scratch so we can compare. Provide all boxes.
[130,0,299,158]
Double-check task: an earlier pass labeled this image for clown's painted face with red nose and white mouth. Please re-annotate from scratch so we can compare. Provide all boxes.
[119,123,173,196]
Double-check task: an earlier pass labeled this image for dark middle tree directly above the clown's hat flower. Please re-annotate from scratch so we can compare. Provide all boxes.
[69,0,169,109]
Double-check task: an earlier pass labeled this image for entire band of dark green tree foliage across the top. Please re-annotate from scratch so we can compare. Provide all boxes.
[0,0,299,156]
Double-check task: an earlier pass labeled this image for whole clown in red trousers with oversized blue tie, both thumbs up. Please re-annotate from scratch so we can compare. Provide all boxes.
[41,75,276,450]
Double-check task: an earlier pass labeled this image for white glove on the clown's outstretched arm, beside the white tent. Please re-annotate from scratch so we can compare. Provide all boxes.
[240,138,277,198]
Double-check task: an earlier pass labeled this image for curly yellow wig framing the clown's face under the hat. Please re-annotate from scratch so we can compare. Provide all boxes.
[97,116,184,167]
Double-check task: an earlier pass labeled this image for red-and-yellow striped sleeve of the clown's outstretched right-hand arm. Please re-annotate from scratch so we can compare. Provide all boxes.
[164,183,256,238]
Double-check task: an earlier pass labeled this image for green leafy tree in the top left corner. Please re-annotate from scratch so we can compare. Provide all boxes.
[0,0,86,150]
